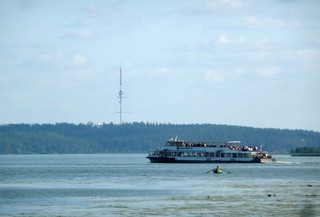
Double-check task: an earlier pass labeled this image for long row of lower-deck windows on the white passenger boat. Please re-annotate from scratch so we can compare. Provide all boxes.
[150,151,251,158]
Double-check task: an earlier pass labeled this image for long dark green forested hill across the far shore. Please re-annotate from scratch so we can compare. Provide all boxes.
[0,123,320,154]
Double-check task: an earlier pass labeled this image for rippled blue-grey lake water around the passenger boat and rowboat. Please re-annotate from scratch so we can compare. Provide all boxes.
[0,154,320,217]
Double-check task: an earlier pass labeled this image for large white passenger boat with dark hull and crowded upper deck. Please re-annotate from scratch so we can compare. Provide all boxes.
[147,139,272,163]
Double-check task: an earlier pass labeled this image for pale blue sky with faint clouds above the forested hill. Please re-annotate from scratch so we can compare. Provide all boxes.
[0,0,320,132]
